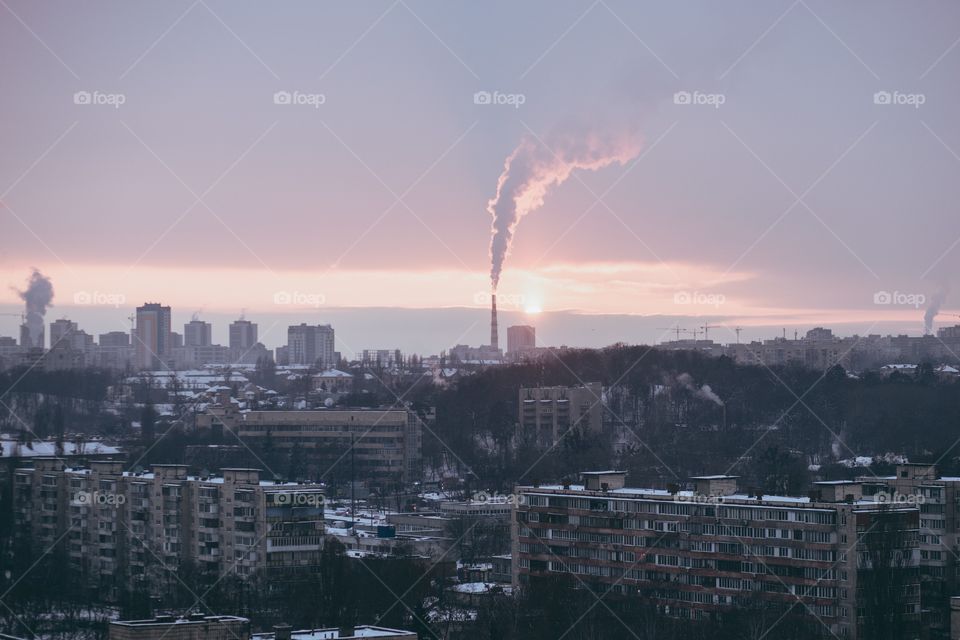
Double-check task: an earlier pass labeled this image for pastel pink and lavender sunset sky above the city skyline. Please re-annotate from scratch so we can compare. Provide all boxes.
[0,0,960,353]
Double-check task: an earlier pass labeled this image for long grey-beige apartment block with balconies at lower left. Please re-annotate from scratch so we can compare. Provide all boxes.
[13,458,324,595]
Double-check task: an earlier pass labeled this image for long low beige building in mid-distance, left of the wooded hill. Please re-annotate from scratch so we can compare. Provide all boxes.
[197,401,422,485]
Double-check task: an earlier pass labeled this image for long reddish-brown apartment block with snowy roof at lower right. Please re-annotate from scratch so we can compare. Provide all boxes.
[512,471,920,640]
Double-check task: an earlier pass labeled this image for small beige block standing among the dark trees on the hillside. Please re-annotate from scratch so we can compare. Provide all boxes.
[518,382,603,446]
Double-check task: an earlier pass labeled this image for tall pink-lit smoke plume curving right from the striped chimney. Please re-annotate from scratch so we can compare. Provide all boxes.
[487,127,641,291]
